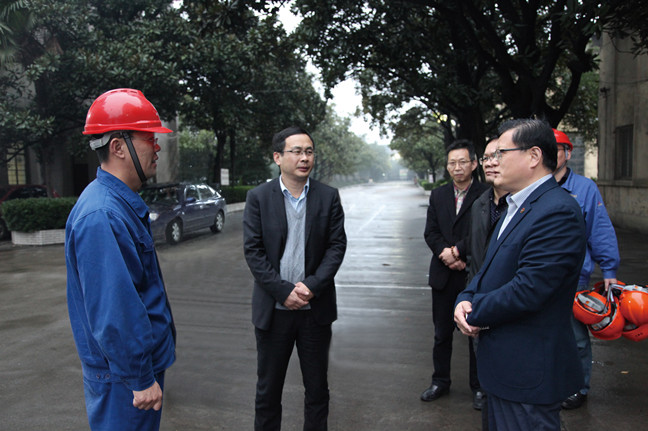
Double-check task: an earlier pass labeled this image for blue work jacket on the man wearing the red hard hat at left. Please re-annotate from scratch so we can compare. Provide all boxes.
[65,168,175,391]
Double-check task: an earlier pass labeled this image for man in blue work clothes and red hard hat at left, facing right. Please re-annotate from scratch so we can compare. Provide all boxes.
[65,89,175,431]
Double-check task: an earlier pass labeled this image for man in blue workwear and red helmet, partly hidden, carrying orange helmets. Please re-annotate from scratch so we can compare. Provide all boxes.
[554,129,620,410]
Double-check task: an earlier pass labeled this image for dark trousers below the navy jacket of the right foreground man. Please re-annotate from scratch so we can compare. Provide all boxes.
[487,394,560,431]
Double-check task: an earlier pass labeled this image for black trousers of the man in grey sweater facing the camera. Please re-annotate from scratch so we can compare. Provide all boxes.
[254,310,331,431]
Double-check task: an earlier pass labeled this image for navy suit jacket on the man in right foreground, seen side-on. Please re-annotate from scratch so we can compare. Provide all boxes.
[457,177,586,404]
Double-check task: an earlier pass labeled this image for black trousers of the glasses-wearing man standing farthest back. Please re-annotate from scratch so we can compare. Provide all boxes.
[432,280,480,391]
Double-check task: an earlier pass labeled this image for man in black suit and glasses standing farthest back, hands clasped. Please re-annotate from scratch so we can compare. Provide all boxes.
[421,140,488,409]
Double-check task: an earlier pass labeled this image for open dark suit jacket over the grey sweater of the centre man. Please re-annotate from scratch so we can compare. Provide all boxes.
[243,178,346,330]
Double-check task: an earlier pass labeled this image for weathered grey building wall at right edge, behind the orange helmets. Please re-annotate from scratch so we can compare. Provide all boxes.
[598,34,648,232]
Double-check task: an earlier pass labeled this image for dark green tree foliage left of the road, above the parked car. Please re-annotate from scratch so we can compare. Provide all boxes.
[0,0,332,189]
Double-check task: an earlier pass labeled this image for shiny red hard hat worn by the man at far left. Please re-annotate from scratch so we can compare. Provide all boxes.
[83,88,171,135]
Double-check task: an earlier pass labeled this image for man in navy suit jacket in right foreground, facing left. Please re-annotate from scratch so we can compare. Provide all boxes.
[454,119,586,431]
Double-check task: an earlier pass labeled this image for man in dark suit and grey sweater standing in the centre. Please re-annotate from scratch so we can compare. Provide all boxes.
[243,127,346,431]
